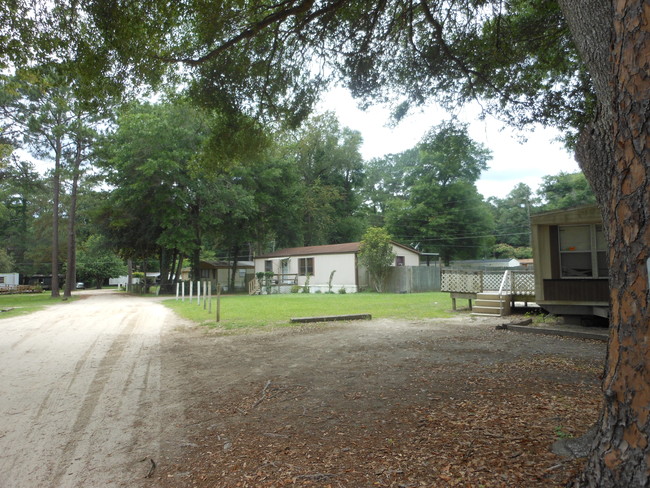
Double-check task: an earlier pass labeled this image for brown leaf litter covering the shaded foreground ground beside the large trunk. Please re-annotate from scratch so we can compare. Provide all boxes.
[152,354,602,488]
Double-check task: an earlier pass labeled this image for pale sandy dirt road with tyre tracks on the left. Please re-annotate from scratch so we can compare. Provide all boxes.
[0,292,182,488]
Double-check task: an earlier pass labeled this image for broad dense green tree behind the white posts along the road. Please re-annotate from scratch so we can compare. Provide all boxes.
[99,101,209,285]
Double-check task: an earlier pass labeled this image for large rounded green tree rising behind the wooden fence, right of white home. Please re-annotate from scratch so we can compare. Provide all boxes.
[386,122,493,263]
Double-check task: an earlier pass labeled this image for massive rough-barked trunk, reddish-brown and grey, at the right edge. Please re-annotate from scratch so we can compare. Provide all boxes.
[560,0,650,487]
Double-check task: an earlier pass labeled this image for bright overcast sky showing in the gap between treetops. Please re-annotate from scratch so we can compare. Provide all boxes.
[318,88,579,198]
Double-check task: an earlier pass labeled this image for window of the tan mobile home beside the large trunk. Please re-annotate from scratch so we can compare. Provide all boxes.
[559,225,608,278]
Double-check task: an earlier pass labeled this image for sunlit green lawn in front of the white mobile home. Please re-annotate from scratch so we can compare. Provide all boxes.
[163,293,452,329]
